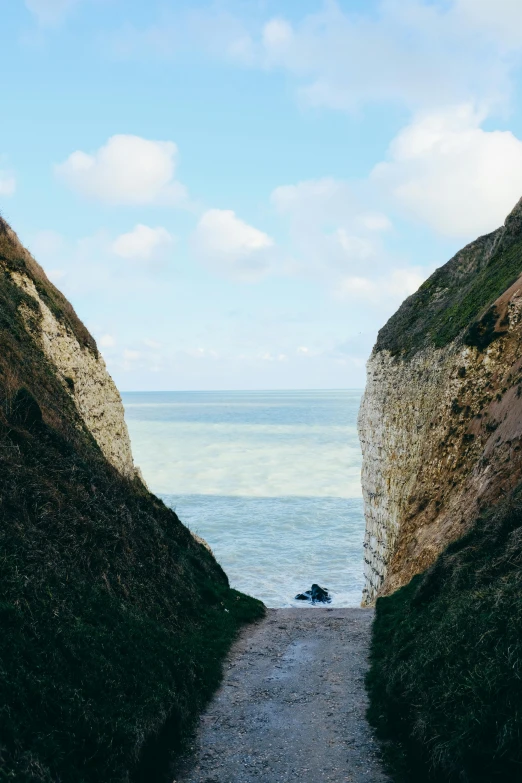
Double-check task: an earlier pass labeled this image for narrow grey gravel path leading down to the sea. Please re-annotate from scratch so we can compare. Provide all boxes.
[174,608,389,783]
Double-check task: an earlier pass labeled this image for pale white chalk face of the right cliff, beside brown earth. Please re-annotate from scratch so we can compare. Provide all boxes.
[359,346,469,605]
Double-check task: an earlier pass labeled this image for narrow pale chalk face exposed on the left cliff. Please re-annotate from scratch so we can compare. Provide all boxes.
[11,272,137,478]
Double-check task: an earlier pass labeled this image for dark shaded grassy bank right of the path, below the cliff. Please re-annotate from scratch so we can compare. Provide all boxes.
[367,488,522,783]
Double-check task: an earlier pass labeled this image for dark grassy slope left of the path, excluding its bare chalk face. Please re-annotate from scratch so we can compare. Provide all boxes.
[0,224,264,783]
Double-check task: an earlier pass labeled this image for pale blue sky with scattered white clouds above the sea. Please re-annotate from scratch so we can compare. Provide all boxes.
[0,0,522,390]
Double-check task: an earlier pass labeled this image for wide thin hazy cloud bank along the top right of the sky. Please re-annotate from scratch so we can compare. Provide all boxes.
[99,0,522,119]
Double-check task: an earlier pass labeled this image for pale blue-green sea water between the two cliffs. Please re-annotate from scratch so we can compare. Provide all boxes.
[122,390,364,607]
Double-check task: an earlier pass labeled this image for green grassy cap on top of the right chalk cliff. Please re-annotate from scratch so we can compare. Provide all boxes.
[376,229,522,359]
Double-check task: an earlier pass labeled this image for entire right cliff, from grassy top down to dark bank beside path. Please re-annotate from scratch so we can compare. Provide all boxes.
[359,198,522,783]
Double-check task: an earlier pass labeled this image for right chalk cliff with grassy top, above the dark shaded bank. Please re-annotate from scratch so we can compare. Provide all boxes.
[359,196,522,604]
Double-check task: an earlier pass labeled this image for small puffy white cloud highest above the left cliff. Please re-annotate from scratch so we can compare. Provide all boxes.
[55,134,187,206]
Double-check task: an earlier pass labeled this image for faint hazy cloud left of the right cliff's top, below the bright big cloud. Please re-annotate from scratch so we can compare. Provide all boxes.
[271,170,431,302]
